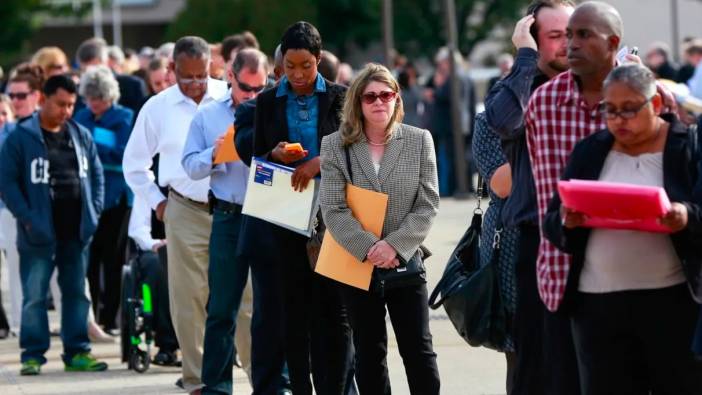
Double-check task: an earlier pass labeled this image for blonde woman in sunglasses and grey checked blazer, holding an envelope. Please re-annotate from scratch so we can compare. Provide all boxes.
[320,63,440,394]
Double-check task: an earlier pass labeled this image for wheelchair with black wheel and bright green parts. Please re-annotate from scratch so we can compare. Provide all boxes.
[120,248,157,373]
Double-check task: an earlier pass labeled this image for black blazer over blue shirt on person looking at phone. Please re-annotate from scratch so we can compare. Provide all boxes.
[254,80,346,161]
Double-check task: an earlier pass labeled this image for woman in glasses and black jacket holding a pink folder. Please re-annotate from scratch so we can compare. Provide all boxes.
[544,64,702,395]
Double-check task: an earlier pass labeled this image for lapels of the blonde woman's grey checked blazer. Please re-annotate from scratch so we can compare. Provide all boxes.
[351,125,405,192]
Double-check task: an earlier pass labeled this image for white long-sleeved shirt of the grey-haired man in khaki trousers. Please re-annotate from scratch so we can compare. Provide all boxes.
[122,79,227,209]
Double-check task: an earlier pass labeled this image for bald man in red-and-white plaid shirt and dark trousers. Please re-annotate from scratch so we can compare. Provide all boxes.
[525,1,676,394]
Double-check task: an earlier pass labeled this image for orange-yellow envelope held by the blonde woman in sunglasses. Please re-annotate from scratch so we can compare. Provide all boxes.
[315,184,388,291]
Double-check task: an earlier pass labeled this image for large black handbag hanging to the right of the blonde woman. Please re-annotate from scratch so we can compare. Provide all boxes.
[429,179,507,350]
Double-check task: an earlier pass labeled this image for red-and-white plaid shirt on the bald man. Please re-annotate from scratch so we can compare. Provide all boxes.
[526,71,607,311]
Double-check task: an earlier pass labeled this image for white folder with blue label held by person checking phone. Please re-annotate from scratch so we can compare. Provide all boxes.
[241,157,319,237]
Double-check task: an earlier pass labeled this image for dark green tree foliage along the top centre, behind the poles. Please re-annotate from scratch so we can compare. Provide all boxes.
[166,0,529,60]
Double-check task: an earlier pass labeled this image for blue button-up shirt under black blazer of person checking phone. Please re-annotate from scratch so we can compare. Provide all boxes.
[276,73,327,161]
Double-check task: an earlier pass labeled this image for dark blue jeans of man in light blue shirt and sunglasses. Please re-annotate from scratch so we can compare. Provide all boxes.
[202,209,249,394]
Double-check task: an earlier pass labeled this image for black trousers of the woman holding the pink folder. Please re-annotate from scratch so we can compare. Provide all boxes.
[571,284,702,395]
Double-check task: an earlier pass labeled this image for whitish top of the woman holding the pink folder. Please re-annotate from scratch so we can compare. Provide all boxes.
[578,150,685,293]
